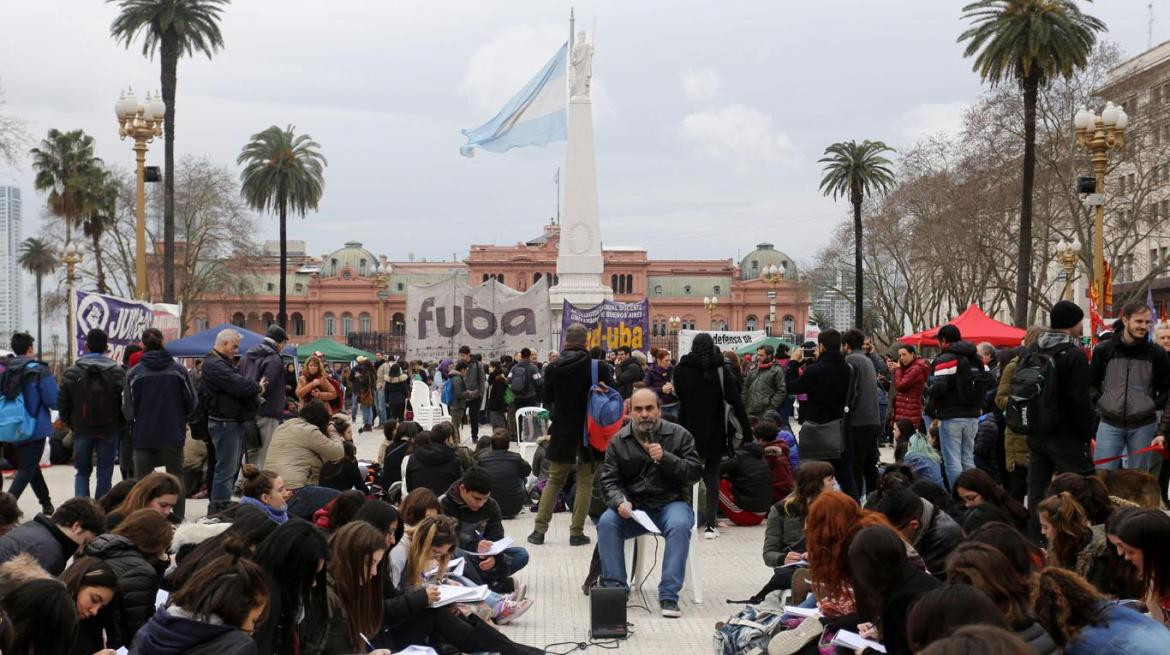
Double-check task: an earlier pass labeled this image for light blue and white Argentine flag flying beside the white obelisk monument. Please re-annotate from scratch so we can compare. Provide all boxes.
[459,42,569,157]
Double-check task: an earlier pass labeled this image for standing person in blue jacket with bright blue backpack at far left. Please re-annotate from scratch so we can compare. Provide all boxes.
[0,332,57,515]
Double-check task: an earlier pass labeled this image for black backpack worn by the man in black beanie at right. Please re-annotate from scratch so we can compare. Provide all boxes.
[1004,347,1060,434]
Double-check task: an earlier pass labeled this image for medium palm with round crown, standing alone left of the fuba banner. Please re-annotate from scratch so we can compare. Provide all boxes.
[236,125,329,328]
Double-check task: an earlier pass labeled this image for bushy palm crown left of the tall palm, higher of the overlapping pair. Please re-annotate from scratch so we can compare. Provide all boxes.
[29,129,102,246]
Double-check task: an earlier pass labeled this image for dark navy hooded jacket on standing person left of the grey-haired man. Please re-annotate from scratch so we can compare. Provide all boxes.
[122,350,196,448]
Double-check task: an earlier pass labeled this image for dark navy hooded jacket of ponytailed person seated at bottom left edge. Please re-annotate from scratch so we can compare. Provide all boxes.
[130,606,256,655]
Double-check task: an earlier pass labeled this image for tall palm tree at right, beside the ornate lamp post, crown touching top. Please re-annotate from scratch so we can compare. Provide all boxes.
[958,0,1106,328]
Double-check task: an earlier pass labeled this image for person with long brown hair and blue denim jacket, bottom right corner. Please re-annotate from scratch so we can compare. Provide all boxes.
[1032,566,1170,655]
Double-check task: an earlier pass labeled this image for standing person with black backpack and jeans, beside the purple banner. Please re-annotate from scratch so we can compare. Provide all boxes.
[57,328,126,498]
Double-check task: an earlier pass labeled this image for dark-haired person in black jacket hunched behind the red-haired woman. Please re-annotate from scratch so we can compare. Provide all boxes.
[874,488,963,579]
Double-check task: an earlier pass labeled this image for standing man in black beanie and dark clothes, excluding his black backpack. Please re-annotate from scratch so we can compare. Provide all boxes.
[1020,301,1095,539]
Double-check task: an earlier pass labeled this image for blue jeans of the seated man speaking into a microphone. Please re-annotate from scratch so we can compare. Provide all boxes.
[597,501,695,601]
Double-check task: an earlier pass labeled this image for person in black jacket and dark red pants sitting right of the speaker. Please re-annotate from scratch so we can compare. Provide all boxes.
[720,421,792,525]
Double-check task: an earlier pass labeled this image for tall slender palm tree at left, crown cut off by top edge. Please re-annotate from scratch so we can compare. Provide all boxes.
[106,0,228,303]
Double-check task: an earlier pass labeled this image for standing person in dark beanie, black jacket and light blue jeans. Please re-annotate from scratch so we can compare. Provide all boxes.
[927,324,991,489]
